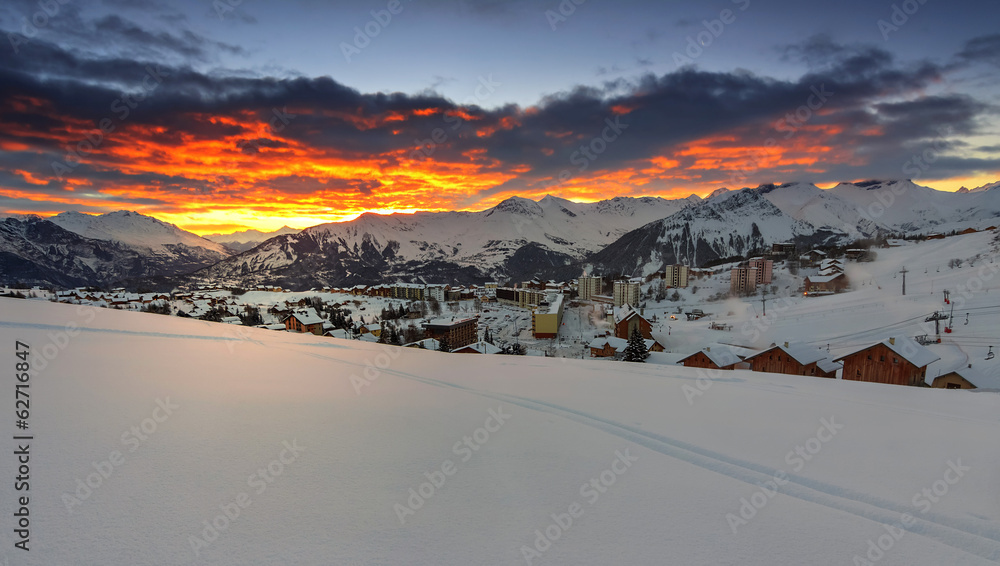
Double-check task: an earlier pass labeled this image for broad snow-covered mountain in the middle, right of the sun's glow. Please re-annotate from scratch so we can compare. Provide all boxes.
[197,195,701,286]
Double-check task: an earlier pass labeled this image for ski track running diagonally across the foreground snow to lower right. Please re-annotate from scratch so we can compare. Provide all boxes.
[292,346,1000,562]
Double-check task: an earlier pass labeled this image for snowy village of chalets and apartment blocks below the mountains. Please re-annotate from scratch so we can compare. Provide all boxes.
[7,232,1000,389]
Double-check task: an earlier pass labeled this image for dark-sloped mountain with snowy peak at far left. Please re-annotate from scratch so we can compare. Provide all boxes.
[0,211,232,287]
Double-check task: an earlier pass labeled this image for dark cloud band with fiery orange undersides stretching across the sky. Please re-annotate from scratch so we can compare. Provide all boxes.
[0,27,997,209]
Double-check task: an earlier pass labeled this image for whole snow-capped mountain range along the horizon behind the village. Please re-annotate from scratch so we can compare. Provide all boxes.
[0,181,1000,288]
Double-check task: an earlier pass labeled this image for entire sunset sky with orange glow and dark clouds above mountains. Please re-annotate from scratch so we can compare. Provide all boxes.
[0,0,1000,234]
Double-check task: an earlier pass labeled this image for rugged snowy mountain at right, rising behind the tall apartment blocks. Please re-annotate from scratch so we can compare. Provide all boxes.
[587,180,1000,275]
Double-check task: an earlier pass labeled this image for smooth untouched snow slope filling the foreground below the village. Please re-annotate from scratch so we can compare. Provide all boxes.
[0,299,1000,566]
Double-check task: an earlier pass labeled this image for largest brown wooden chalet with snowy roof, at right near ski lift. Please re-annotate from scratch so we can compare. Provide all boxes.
[834,337,941,386]
